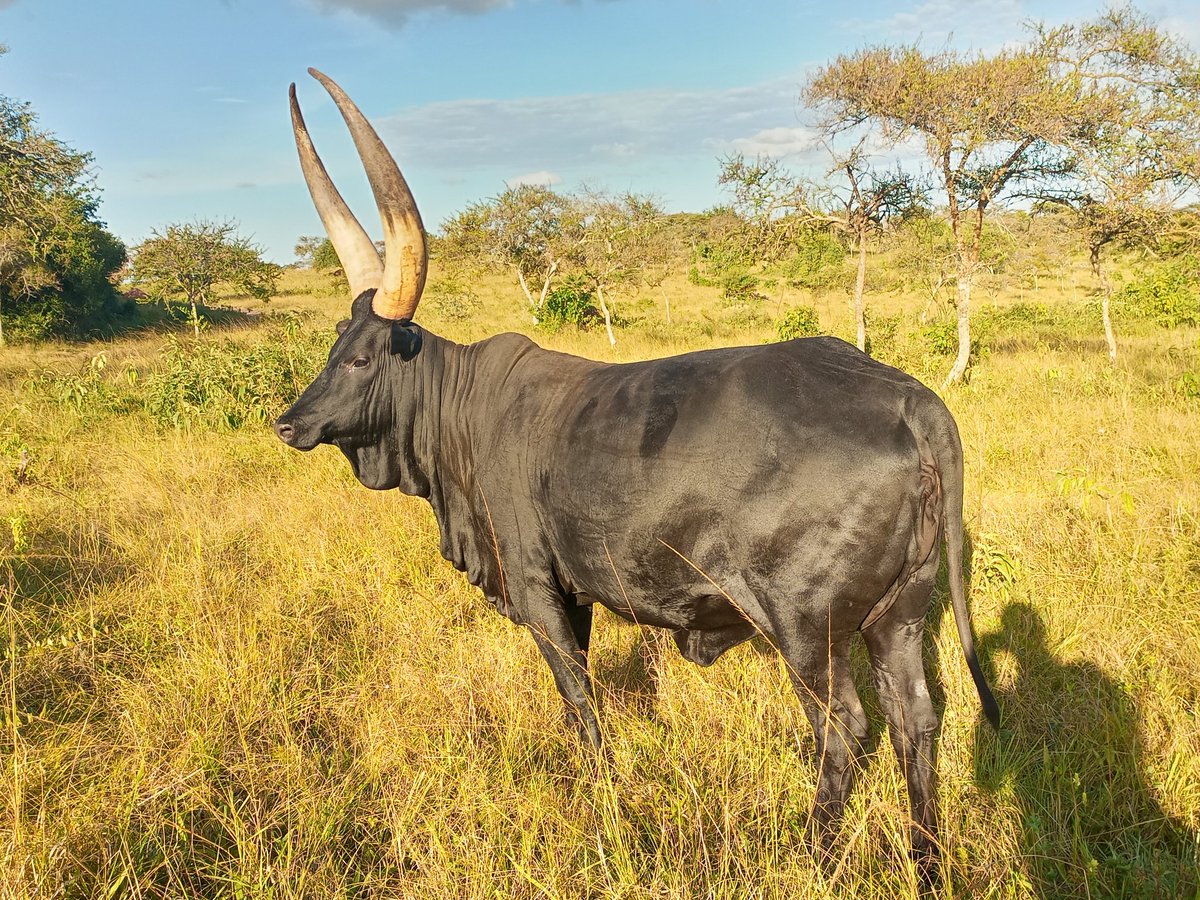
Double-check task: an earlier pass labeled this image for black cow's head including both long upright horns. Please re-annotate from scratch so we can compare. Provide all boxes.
[275,68,428,490]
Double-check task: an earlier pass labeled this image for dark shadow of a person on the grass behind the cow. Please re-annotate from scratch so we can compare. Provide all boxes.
[974,602,1200,898]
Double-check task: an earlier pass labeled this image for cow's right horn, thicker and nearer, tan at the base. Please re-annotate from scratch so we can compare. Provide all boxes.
[308,68,430,319]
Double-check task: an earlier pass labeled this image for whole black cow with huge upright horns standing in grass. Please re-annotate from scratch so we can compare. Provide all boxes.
[275,70,998,871]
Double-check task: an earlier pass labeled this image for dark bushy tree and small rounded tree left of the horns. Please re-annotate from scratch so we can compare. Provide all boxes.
[0,44,280,344]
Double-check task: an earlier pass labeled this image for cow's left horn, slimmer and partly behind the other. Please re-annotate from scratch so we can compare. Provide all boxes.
[288,84,383,298]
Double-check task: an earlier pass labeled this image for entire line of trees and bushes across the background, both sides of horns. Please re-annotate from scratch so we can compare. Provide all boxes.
[7,7,1200,364]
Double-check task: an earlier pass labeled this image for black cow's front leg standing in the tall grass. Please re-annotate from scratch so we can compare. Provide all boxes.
[529,601,601,750]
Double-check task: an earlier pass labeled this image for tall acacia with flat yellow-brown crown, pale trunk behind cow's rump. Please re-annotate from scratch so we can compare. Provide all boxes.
[804,47,1073,384]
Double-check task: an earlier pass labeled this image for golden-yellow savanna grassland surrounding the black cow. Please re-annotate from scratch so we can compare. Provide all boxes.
[0,262,1200,900]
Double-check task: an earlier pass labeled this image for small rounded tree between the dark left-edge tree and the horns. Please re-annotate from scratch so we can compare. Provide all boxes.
[130,221,280,336]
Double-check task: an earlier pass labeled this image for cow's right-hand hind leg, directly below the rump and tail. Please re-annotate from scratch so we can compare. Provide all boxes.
[863,571,938,882]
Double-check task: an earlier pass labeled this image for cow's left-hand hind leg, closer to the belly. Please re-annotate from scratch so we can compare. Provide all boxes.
[780,635,869,860]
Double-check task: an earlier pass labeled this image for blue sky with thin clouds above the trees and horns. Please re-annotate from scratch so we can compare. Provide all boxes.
[0,0,1200,263]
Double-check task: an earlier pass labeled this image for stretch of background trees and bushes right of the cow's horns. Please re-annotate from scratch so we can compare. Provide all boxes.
[343,7,1200,382]
